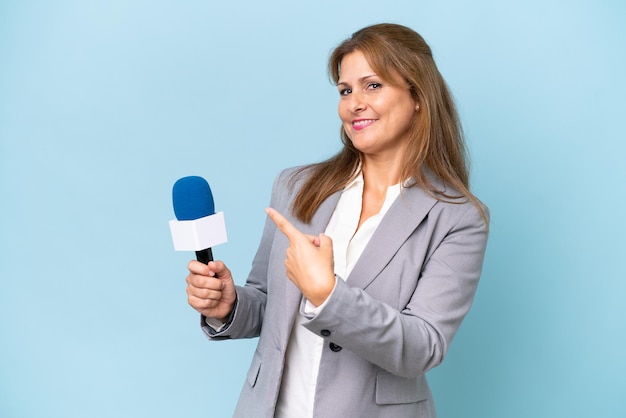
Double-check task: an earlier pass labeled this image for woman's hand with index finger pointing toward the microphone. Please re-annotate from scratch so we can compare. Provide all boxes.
[265,208,335,306]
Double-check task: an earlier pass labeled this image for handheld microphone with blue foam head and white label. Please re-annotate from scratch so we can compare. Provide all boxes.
[169,176,228,264]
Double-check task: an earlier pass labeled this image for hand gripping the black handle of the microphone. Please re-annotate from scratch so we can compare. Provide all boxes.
[187,260,237,322]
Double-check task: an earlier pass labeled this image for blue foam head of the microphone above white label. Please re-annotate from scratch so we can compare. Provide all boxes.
[172,176,215,221]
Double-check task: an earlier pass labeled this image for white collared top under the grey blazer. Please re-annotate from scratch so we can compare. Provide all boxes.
[274,175,400,418]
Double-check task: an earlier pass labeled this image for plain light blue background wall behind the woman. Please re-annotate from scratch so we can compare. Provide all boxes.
[0,0,626,418]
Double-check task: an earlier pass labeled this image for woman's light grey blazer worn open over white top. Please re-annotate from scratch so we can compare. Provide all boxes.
[201,169,487,418]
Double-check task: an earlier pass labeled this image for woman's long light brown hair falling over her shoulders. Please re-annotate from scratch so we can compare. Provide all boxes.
[291,23,486,223]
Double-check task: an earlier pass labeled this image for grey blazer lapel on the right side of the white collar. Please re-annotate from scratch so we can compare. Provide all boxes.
[346,186,437,289]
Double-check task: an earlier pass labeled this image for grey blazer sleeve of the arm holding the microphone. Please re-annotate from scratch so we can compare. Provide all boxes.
[200,171,288,340]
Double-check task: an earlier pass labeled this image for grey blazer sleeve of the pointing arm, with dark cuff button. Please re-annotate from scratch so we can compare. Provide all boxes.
[298,204,487,377]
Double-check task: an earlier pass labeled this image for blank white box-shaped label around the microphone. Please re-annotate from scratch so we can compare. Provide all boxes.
[170,212,228,251]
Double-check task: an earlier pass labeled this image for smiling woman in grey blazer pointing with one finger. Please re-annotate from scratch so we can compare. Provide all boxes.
[187,24,488,418]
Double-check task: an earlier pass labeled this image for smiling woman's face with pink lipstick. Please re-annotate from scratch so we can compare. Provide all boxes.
[337,51,418,158]
